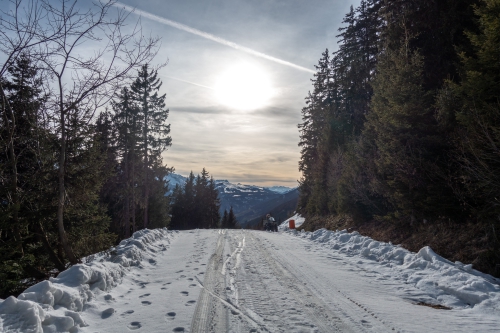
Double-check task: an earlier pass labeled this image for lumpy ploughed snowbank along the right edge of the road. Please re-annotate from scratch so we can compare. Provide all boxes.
[287,229,500,314]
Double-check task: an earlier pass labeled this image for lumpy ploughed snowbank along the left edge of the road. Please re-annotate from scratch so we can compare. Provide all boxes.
[0,228,173,333]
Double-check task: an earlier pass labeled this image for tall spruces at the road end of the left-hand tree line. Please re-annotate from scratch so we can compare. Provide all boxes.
[108,65,172,238]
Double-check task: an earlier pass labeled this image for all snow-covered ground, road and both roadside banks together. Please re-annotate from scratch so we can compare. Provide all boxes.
[0,224,500,333]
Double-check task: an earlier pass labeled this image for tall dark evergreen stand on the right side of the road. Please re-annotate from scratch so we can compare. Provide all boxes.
[299,0,500,242]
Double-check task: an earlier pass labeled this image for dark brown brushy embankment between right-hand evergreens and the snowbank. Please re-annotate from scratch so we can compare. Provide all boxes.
[300,216,500,277]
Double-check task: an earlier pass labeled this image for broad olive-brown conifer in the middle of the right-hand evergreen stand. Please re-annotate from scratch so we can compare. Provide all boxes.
[365,25,457,222]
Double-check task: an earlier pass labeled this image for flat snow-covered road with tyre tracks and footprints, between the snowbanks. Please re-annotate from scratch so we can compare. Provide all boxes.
[0,230,500,333]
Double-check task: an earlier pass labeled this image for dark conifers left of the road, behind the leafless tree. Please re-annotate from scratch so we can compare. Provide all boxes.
[0,54,171,296]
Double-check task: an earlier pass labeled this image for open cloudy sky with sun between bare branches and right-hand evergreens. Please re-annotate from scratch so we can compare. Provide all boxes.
[113,0,359,187]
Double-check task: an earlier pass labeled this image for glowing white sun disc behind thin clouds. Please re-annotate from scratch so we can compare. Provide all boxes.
[215,63,273,110]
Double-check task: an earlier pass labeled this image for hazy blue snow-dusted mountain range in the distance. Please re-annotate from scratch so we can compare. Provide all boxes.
[167,173,299,226]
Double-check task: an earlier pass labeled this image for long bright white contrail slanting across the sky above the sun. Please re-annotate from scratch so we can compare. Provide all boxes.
[114,2,315,73]
